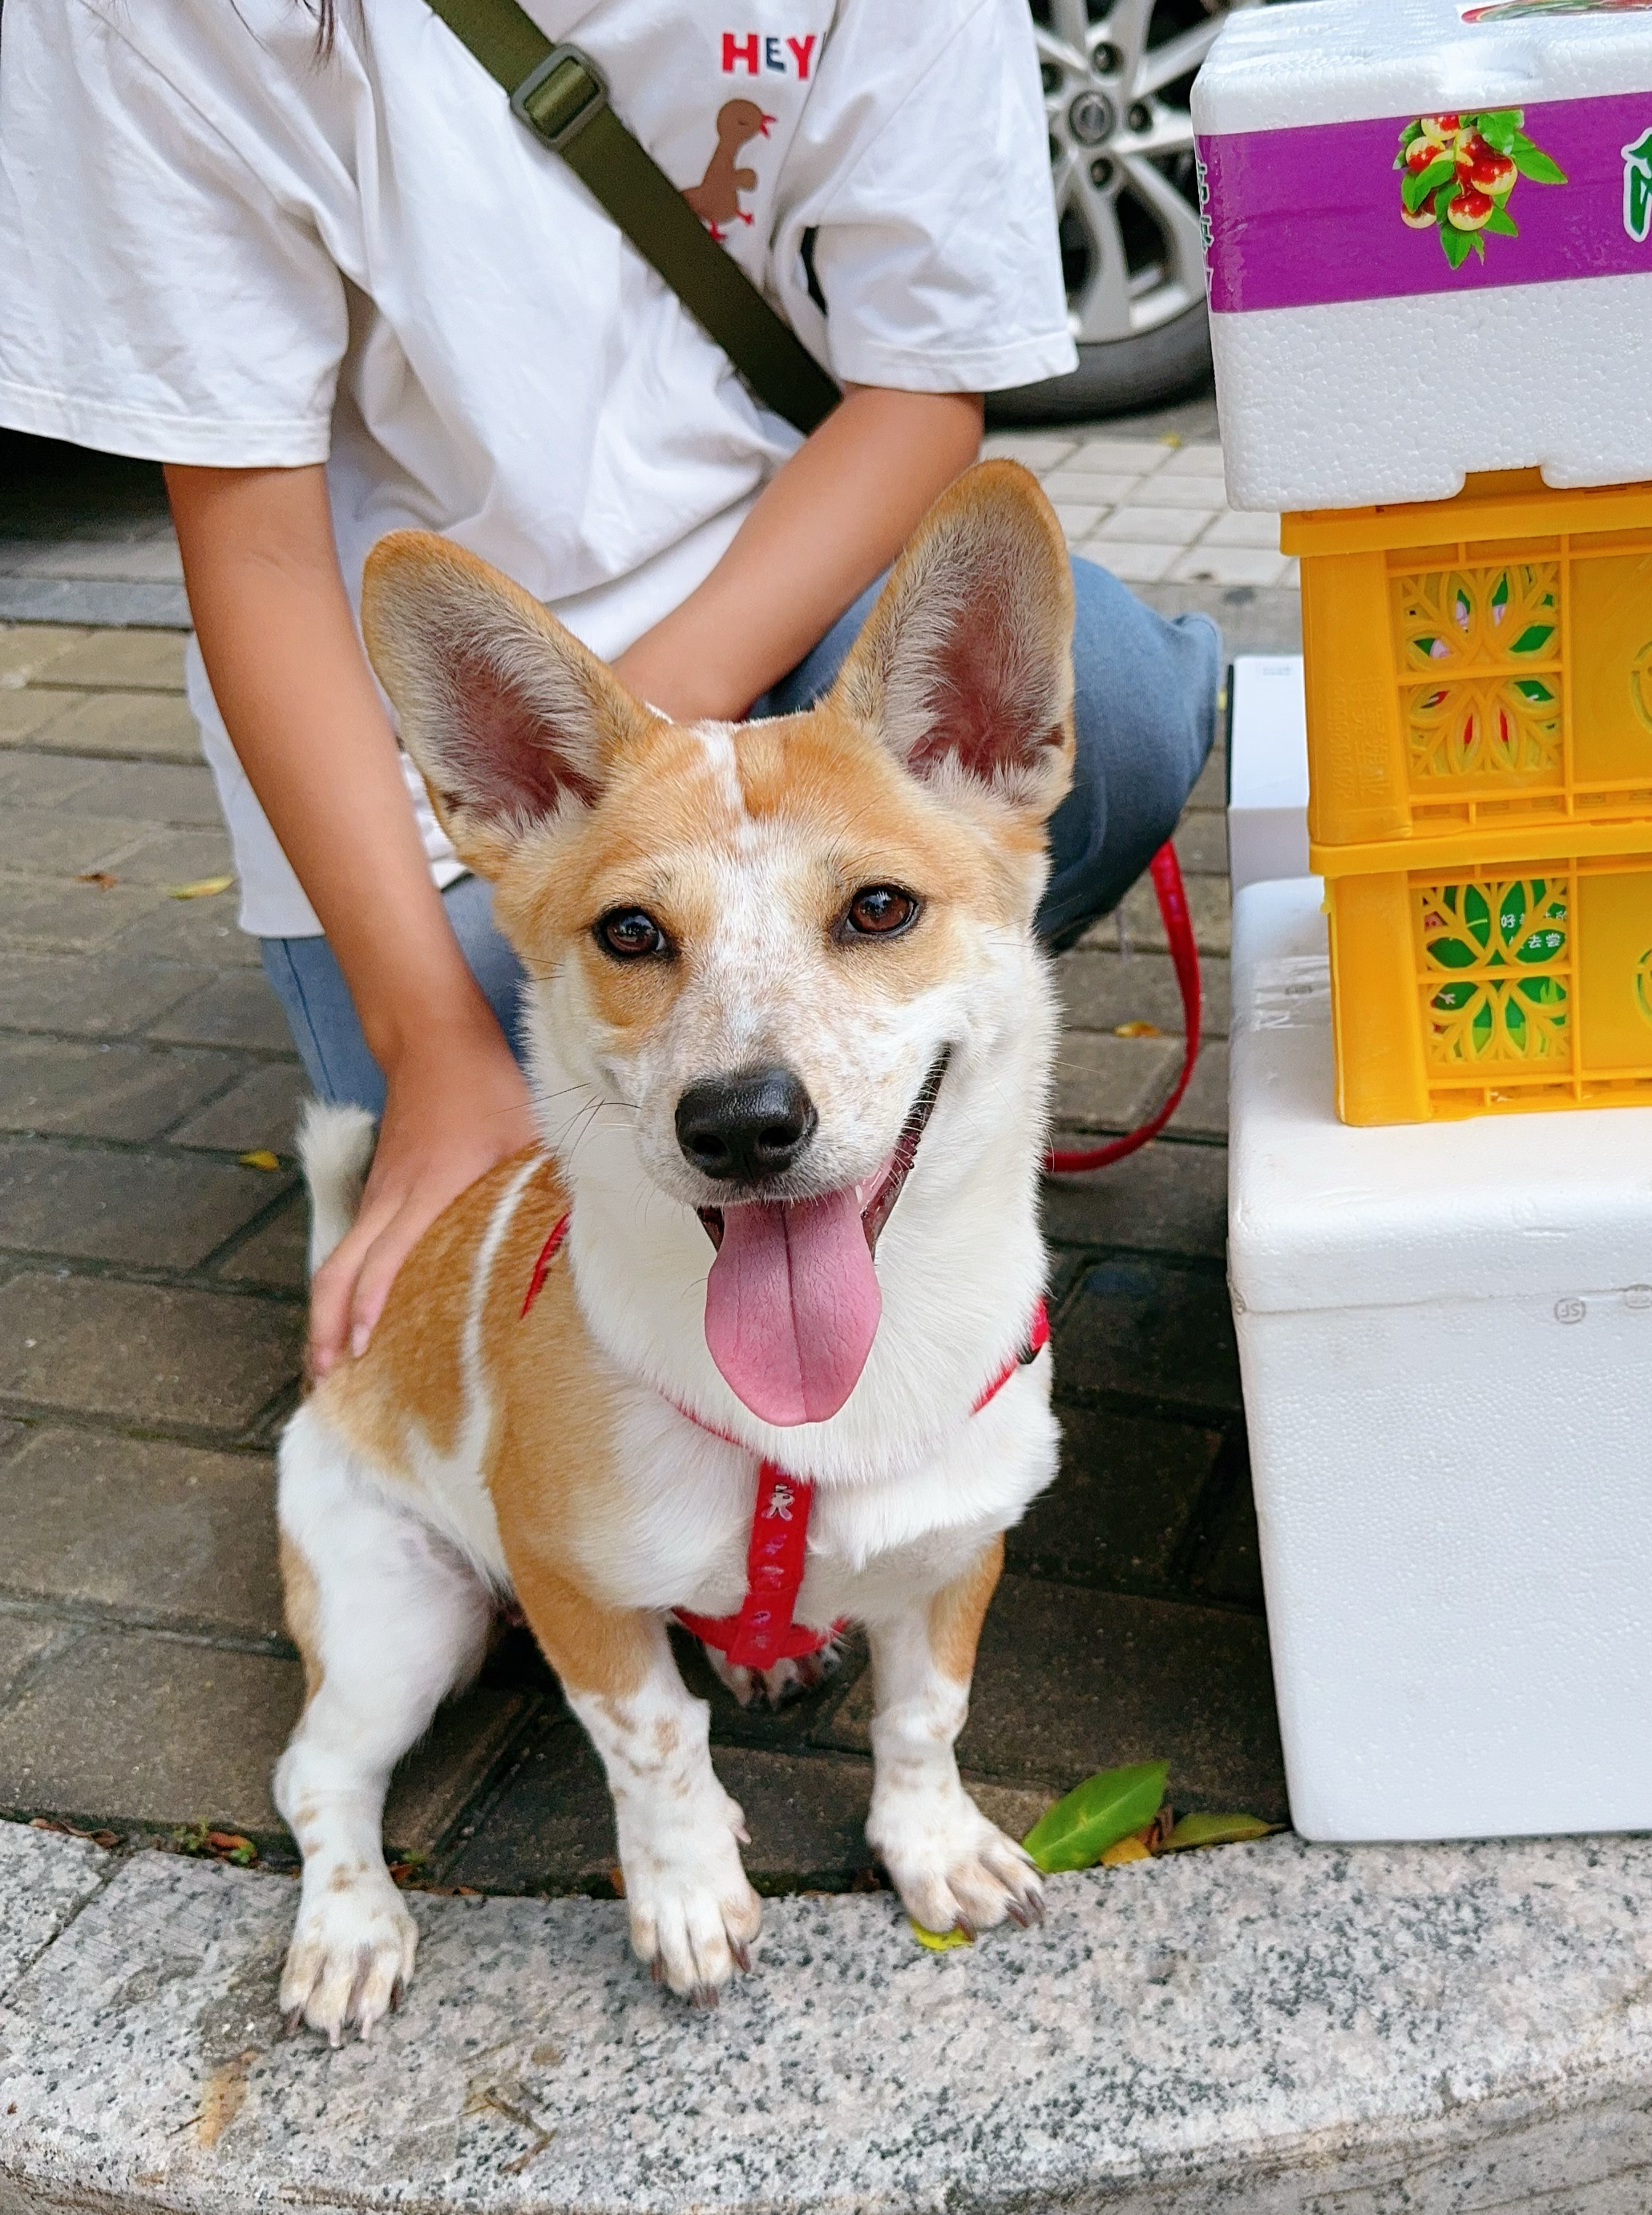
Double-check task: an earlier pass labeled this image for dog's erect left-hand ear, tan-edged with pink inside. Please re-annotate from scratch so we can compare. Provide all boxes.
[361,532,647,877]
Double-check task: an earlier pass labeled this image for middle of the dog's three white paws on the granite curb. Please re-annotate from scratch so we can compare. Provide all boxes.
[620,1801,761,2007]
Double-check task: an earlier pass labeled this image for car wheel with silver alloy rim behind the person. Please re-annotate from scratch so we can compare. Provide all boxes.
[988,0,1258,423]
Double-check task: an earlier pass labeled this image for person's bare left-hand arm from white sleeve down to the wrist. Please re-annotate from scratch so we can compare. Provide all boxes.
[166,467,490,1068]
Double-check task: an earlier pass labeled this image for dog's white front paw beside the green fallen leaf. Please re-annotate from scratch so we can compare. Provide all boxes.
[866,1785,1043,1936]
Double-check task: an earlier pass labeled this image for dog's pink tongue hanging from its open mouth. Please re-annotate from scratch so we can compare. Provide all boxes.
[706,1190,883,1422]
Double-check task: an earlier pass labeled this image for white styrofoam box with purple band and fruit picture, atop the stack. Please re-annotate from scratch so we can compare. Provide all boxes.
[1194,0,1652,509]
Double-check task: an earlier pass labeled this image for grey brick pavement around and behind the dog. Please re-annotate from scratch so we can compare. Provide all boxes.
[0,422,1295,1890]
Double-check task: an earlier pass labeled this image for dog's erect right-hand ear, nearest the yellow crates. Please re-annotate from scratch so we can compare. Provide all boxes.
[833,461,1072,818]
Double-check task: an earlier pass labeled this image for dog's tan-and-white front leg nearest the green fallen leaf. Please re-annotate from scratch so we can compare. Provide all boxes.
[866,1538,1043,1931]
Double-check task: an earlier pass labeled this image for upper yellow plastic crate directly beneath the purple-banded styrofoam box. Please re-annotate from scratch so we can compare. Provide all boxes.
[1282,470,1652,868]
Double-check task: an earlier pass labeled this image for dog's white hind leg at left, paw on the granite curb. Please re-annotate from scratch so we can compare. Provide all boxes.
[275,1407,494,2047]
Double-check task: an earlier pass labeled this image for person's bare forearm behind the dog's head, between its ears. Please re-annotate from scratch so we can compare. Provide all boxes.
[613,386,981,720]
